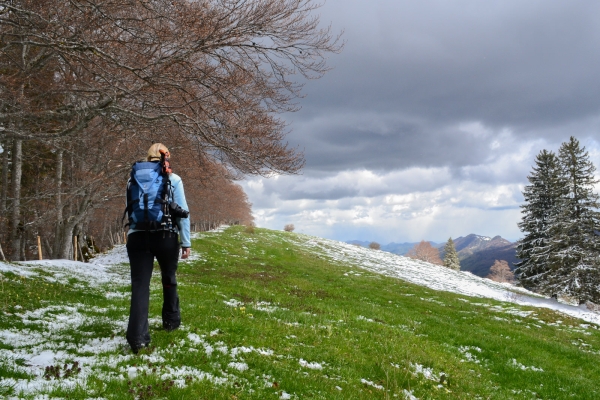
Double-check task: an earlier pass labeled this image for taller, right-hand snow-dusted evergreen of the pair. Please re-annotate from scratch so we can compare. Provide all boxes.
[531,137,600,302]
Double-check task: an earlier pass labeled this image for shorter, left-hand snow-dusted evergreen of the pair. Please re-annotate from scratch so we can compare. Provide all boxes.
[515,150,566,290]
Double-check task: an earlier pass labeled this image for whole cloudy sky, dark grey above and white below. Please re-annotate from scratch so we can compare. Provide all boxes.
[242,0,600,244]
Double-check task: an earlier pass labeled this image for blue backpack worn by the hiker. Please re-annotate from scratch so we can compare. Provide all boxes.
[123,161,173,231]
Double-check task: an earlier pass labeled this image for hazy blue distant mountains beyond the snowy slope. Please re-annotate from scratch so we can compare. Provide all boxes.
[348,234,518,277]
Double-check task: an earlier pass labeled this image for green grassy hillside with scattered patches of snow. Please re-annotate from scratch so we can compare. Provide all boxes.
[0,227,600,399]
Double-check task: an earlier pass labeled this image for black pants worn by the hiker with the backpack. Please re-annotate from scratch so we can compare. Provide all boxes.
[127,232,181,348]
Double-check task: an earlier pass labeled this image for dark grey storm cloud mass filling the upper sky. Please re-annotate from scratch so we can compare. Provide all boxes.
[286,0,600,173]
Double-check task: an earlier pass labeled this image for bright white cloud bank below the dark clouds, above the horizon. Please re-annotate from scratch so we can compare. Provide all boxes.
[242,131,600,243]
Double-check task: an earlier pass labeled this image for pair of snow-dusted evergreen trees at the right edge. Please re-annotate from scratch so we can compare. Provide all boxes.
[515,137,600,303]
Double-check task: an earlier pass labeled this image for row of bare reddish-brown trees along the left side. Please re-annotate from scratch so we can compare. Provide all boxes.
[0,0,341,260]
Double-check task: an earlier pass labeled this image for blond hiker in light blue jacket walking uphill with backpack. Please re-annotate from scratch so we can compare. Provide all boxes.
[125,143,191,354]
